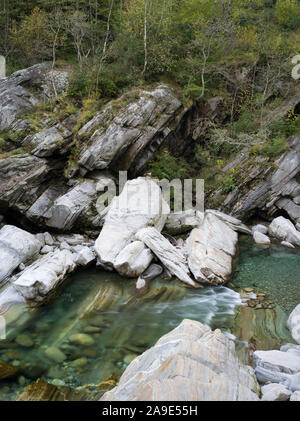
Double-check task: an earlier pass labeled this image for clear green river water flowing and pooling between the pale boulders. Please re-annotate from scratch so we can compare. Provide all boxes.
[0,239,300,400]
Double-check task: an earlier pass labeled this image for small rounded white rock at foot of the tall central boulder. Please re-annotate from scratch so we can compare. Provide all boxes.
[114,241,153,278]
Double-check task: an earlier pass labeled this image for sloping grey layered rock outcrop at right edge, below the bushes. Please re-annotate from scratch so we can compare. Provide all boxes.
[224,136,300,224]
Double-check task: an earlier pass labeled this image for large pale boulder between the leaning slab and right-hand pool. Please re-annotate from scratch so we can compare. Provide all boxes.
[186,212,238,285]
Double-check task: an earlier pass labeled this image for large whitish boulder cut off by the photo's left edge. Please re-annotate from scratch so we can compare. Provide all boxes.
[0,225,42,284]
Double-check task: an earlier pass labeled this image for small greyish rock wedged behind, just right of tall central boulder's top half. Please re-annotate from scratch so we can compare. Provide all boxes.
[164,209,202,235]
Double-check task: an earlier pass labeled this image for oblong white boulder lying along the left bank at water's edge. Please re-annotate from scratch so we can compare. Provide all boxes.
[11,250,76,304]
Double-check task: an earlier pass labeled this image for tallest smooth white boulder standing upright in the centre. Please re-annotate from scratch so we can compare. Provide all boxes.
[95,177,170,267]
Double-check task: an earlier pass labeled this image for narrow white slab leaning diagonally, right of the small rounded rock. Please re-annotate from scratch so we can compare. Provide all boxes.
[136,227,196,286]
